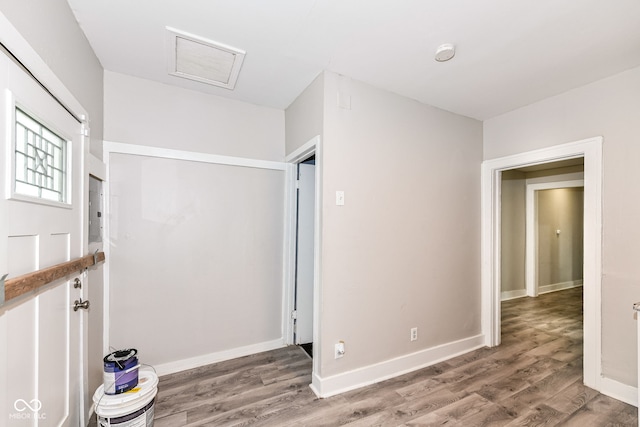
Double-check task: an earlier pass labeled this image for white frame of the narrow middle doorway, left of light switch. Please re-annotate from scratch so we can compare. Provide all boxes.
[282,136,322,362]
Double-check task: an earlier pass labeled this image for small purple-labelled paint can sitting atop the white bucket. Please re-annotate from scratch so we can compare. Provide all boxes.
[102,348,140,394]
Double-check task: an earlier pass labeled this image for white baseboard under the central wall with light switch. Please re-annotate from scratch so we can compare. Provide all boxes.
[310,335,485,398]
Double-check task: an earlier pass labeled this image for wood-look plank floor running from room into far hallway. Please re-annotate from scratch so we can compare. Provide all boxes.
[110,288,638,427]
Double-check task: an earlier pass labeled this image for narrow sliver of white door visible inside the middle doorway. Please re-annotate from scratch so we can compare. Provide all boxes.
[296,163,316,344]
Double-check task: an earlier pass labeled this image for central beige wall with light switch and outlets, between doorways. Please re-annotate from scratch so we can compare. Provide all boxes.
[316,73,482,388]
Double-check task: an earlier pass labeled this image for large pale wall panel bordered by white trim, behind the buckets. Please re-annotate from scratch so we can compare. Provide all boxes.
[109,154,284,373]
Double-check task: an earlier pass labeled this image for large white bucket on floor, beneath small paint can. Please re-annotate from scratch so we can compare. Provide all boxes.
[93,370,158,427]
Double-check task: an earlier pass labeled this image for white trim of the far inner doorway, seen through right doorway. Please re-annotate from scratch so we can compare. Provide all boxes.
[524,179,584,297]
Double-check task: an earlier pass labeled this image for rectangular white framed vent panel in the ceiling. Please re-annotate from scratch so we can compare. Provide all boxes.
[167,27,245,89]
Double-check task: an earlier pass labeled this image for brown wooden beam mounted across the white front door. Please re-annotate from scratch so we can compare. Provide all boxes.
[0,252,105,306]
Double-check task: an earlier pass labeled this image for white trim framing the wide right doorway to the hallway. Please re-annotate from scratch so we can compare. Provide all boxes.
[481,137,603,391]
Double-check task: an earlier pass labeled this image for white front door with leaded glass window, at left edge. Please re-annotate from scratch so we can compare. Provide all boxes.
[0,54,86,427]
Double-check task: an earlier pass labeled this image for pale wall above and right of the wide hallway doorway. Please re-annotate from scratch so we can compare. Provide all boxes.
[484,68,640,386]
